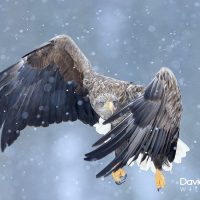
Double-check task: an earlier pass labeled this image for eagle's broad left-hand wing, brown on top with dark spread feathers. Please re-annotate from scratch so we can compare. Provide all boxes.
[0,35,99,151]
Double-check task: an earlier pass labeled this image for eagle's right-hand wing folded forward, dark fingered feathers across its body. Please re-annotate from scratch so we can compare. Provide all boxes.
[85,68,182,177]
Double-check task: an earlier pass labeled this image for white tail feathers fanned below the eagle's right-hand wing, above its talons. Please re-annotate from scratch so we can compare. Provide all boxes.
[127,139,190,173]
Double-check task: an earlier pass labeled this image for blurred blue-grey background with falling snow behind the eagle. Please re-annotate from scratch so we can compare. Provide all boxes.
[0,0,200,200]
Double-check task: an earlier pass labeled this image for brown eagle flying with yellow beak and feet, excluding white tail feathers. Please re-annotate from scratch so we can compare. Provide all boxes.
[0,35,189,188]
